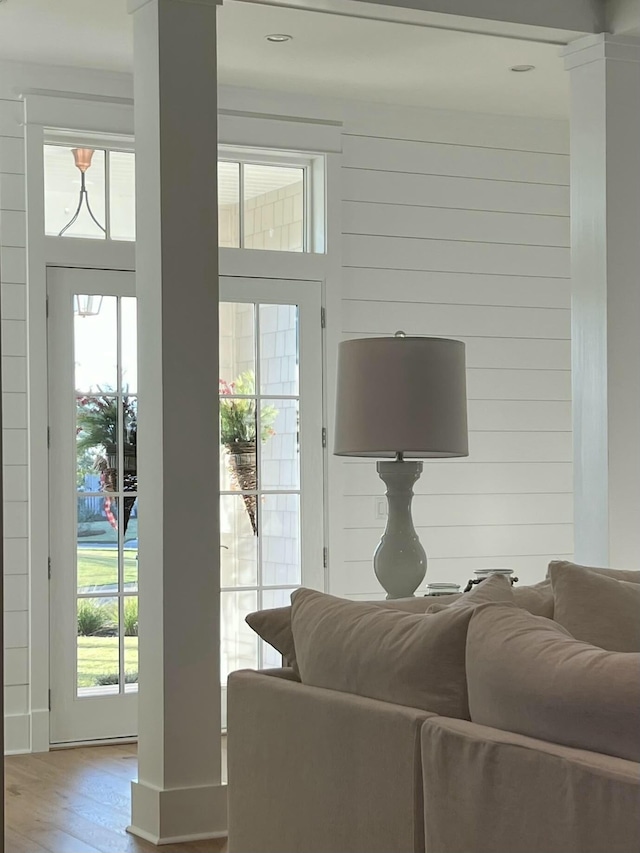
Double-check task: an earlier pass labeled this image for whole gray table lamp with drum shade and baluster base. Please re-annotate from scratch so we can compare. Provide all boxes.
[333,332,469,598]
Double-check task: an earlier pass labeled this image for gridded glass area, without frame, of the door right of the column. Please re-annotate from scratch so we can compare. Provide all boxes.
[220,300,304,683]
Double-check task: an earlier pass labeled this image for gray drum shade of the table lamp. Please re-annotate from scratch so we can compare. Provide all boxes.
[333,336,469,459]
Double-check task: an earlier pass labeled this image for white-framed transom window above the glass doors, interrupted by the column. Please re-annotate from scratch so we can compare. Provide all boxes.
[43,140,324,252]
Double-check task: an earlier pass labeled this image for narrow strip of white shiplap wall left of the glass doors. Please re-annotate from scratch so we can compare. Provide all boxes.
[0,100,30,751]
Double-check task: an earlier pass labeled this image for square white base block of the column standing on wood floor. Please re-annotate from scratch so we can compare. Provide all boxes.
[127,782,227,844]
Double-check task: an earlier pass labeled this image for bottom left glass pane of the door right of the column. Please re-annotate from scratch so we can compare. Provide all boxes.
[220,590,258,684]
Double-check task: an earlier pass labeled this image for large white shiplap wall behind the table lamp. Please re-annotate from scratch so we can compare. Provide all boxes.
[330,113,573,598]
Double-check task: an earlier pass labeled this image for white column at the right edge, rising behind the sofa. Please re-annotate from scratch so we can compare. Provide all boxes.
[563,34,640,568]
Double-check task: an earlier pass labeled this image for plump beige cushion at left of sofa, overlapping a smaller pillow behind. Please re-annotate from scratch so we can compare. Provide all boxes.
[291,579,516,719]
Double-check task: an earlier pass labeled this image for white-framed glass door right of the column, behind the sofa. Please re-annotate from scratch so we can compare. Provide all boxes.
[219,278,324,716]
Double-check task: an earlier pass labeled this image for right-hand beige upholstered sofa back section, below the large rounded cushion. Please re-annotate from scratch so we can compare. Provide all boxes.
[422,717,640,853]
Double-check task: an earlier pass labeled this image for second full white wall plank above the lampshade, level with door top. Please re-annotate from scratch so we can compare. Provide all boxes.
[342,267,571,309]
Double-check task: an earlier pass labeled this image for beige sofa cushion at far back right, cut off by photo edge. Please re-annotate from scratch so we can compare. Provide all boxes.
[549,564,640,652]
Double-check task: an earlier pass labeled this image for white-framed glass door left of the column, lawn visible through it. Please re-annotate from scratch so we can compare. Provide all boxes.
[48,269,138,742]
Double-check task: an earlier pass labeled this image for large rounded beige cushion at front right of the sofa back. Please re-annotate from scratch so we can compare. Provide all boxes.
[466,605,640,761]
